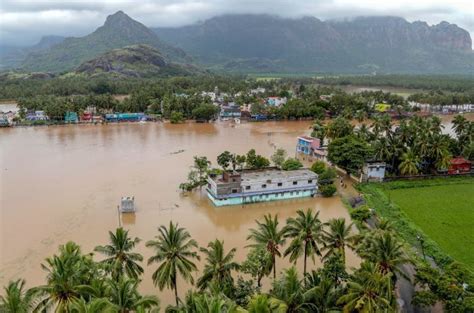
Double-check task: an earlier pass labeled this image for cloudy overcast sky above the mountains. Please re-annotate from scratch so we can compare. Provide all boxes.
[0,0,474,45]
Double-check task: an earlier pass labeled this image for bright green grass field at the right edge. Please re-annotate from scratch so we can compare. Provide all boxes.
[383,178,474,271]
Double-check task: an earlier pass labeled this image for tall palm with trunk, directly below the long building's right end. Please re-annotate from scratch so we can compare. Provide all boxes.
[283,209,323,276]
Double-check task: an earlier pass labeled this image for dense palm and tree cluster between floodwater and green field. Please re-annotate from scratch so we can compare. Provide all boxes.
[320,115,474,175]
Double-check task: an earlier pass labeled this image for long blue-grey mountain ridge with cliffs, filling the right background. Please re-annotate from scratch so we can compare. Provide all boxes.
[154,14,474,73]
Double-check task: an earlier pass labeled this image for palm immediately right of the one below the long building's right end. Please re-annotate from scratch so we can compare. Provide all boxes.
[323,218,354,263]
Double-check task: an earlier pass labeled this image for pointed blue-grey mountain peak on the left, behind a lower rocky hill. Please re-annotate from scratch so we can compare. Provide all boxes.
[21,11,189,72]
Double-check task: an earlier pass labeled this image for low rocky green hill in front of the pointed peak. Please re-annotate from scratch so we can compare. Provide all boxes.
[76,45,202,77]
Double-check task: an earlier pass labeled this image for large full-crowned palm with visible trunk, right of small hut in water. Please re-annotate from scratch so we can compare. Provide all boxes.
[146,221,200,305]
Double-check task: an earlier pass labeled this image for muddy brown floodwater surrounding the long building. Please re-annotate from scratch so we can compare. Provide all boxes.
[0,116,466,307]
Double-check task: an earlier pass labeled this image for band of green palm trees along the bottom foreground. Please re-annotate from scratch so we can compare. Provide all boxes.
[6,209,472,313]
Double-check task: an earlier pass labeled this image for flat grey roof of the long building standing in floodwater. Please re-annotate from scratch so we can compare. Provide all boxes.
[242,169,318,183]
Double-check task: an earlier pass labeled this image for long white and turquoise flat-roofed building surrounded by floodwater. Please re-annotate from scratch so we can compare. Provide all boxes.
[207,168,318,206]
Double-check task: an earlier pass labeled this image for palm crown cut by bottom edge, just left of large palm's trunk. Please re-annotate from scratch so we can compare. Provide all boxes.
[108,277,160,313]
